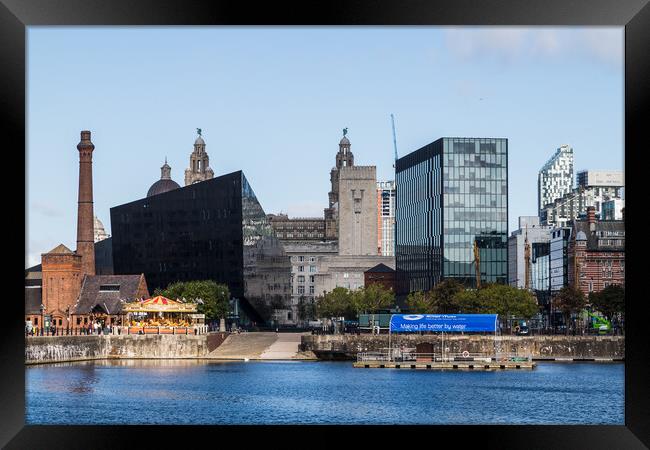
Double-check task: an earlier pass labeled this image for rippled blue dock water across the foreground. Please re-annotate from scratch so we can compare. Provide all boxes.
[26,361,624,424]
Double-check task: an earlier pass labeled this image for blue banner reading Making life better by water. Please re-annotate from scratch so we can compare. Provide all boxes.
[390,314,498,333]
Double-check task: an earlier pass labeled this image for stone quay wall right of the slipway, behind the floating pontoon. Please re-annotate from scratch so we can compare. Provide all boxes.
[300,334,625,361]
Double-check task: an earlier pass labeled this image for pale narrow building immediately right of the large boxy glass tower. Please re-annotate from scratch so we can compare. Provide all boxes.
[508,216,551,288]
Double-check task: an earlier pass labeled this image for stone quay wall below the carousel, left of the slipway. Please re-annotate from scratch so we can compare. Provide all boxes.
[25,333,227,364]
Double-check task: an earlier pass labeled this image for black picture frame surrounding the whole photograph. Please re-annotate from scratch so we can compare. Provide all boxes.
[0,0,650,449]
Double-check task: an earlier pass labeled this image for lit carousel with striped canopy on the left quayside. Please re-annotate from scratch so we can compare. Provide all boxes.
[122,295,205,334]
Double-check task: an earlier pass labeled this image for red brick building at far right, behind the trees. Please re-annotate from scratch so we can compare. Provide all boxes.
[567,207,625,296]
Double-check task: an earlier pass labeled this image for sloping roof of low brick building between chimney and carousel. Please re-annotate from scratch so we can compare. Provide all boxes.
[73,275,144,314]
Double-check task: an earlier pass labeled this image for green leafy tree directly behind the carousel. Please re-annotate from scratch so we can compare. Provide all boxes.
[154,280,230,320]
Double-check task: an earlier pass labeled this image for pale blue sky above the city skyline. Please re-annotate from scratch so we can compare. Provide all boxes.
[25,27,624,267]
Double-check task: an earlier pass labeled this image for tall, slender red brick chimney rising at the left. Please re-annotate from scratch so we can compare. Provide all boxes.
[77,131,95,280]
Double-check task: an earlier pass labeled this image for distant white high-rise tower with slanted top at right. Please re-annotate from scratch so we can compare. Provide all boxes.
[537,145,573,214]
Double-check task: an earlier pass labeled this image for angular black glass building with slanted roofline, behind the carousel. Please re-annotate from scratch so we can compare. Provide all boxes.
[111,171,291,322]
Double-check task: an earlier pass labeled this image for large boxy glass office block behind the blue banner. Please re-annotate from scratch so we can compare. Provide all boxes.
[395,138,508,291]
